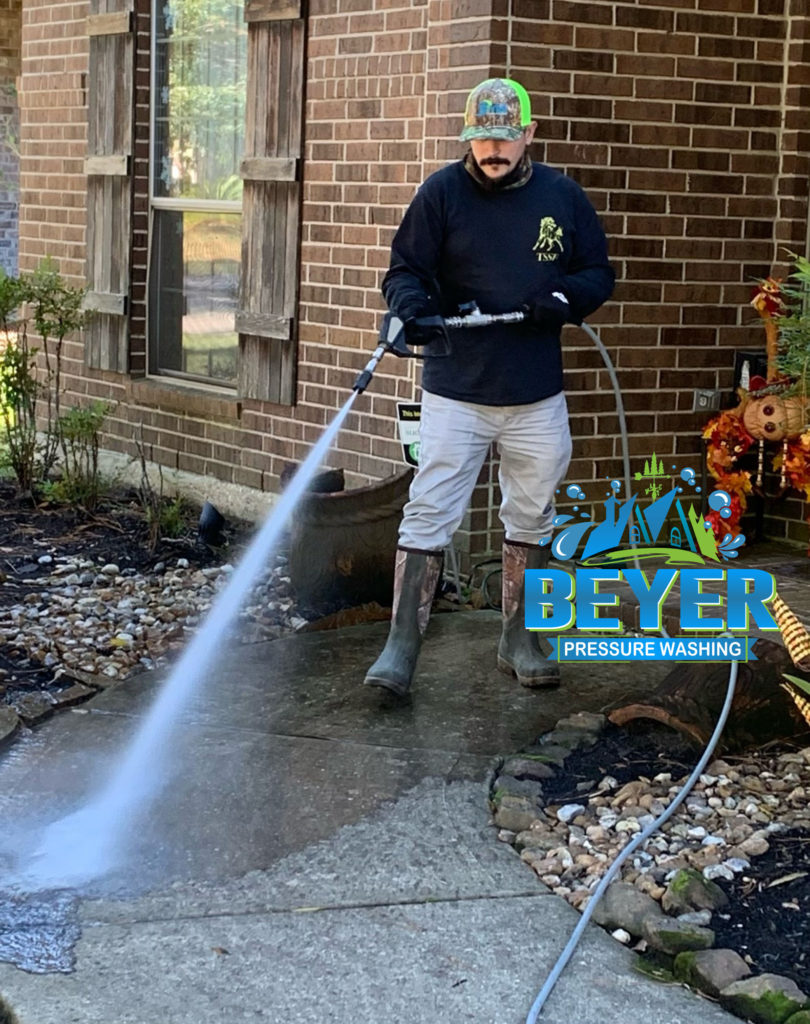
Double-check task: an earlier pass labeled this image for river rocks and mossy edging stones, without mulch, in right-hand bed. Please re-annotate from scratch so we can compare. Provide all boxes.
[487,712,810,1024]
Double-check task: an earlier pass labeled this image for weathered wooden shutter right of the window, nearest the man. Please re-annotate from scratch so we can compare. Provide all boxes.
[237,0,306,404]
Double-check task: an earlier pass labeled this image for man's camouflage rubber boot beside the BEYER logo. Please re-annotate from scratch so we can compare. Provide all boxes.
[498,541,560,689]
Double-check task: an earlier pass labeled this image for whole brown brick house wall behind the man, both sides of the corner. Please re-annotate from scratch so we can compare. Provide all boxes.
[14,0,810,554]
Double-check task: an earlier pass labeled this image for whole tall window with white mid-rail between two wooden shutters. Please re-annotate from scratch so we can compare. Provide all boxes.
[148,0,247,387]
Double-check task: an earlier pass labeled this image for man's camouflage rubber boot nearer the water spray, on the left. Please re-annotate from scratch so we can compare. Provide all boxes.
[364,548,442,696]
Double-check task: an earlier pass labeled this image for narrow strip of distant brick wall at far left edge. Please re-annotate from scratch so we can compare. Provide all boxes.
[0,0,22,274]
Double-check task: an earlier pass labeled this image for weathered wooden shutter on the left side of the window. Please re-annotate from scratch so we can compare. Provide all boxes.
[85,0,134,373]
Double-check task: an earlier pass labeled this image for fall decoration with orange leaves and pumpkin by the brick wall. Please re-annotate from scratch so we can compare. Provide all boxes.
[702,253,810,553]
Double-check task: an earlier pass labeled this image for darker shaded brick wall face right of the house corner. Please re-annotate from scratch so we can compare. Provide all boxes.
[481,0,810,552]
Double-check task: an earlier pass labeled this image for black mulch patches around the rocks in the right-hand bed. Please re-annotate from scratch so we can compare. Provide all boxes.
[543,723,810,992]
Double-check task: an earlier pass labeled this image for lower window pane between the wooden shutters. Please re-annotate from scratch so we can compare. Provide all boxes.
[150,210,242,386]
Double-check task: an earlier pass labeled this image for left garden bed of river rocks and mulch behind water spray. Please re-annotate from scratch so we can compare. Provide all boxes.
[0,484,307,741]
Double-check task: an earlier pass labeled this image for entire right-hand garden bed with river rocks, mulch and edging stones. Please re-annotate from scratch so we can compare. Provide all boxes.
[491,713,810,1024]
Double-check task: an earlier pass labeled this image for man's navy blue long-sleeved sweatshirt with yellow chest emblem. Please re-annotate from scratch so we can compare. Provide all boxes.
[382,161,614,406]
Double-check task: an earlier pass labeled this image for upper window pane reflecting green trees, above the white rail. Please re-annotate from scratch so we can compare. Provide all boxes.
[153,0,247,200]
